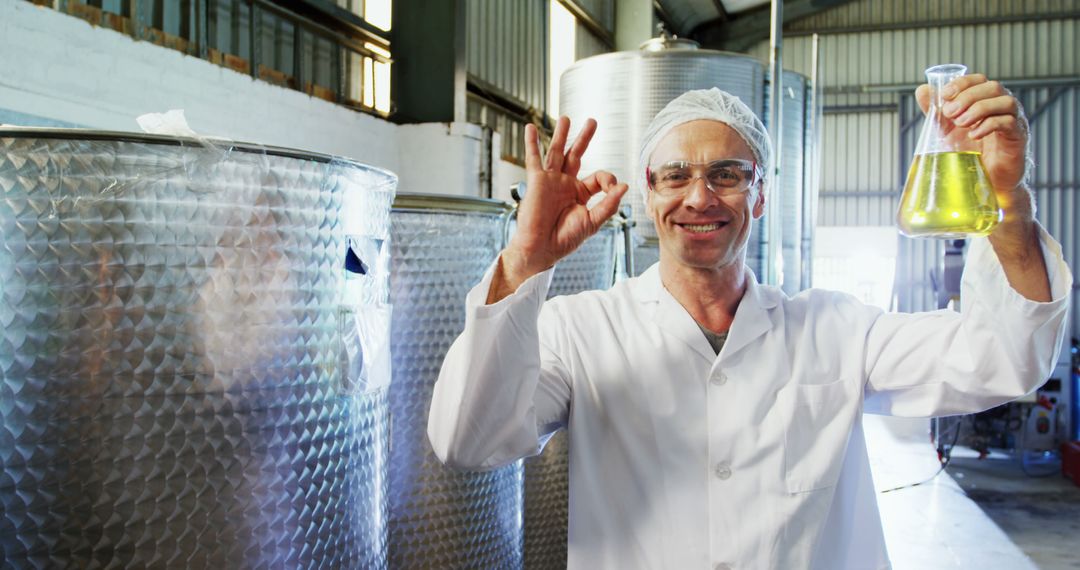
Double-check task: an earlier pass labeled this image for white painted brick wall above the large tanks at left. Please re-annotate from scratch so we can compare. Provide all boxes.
[0,0,535,200]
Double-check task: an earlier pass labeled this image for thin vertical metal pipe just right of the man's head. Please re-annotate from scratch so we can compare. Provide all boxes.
[761,0,784,286]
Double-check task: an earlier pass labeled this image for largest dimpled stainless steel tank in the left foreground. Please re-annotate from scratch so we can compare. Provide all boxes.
[0,130,396,568]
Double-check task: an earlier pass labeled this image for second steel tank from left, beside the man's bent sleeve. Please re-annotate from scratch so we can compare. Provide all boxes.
[390,194,523,569]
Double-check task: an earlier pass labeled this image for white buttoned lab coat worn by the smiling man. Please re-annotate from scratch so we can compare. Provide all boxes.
[428,230,1071,570]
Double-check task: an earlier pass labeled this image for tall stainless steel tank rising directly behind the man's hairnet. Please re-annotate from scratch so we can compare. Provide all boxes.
[559,38,765,238]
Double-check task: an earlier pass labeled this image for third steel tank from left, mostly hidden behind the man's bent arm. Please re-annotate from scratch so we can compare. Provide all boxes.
[524,219,625,570]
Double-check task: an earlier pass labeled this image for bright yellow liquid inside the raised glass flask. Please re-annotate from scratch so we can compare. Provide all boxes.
[896,152,1001,238]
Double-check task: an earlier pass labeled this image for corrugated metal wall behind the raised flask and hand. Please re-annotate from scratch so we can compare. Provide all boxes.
[751,0,1080,335]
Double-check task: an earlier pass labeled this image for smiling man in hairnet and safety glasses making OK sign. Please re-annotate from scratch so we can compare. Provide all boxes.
[428,76,1071,570]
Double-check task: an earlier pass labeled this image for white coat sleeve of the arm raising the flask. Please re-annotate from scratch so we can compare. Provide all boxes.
[865,227,1072,417]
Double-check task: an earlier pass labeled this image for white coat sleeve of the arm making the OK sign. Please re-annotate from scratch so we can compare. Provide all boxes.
[428,258,570,471]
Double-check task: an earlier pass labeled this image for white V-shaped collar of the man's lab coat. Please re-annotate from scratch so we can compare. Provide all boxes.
[632,263,780,362]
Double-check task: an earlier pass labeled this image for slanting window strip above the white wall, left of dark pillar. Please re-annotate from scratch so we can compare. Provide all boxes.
[45,0,392,116]
